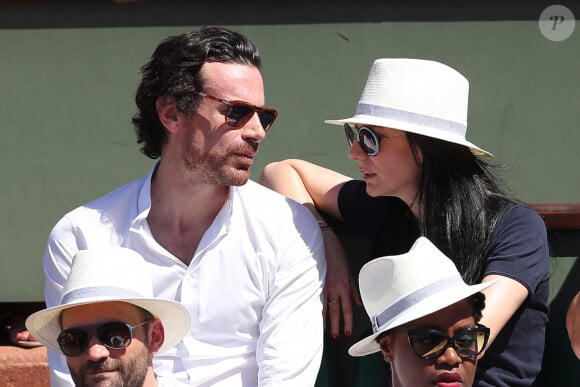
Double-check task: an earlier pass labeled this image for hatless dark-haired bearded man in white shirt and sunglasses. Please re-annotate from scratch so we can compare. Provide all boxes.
[44,27,326,387]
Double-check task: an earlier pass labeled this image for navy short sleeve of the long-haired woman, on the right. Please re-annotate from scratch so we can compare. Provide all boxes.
[484,206,550,295]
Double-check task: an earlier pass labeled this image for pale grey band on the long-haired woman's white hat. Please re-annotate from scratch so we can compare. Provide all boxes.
[356,102,467,138]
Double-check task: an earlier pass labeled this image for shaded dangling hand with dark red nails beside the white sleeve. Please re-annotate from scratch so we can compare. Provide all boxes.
[322,228,362,339]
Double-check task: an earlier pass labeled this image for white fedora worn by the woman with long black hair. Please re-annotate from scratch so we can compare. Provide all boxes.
[324,58,492,156]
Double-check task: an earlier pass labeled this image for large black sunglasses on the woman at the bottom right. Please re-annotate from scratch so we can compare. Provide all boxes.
[394,324,489,360]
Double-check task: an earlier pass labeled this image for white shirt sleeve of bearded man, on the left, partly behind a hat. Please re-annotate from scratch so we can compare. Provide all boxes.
[43,217,80,387]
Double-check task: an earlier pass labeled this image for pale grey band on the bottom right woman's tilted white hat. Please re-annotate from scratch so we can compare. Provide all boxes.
[371,275,465,333]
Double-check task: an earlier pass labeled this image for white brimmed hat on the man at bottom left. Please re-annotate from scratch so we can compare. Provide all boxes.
[26,247,191,353]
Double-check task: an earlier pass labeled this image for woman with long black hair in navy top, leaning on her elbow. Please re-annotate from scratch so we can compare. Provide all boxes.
[260,58,549,387]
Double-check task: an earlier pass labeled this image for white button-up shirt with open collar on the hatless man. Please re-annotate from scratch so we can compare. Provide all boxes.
[44,165,326,387]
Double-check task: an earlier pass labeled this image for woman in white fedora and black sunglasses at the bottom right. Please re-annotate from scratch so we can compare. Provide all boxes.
[349,237,495,387]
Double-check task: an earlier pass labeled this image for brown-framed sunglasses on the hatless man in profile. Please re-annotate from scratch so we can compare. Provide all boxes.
[194,91,278,132]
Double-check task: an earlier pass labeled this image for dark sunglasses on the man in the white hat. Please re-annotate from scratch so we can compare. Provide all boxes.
[56,320,153,357]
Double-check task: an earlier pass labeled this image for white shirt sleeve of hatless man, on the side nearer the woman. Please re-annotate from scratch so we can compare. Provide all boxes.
[256,205,326,387]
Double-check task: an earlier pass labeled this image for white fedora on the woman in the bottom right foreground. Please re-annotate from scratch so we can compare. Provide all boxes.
[348,237,496,356]
